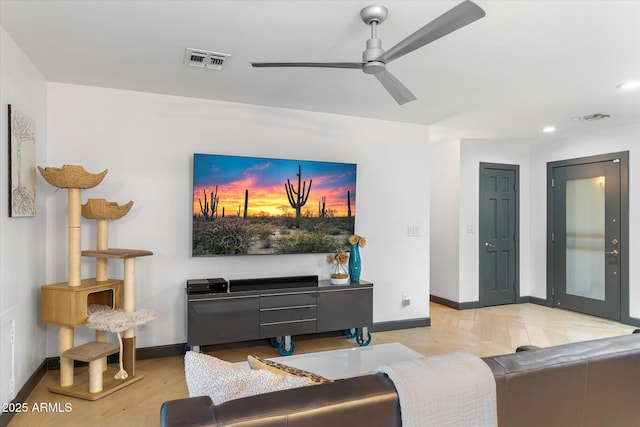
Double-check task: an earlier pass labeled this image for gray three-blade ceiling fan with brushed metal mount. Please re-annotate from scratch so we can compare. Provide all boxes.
[251,0,485,105]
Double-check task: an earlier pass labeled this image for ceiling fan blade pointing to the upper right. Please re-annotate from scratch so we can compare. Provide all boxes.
[377,1,485,64]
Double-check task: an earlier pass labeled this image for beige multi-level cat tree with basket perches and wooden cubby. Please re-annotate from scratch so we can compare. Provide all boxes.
[38,165,155,400]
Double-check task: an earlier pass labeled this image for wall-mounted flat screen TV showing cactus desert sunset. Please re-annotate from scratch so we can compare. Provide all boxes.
[191,154,356,256]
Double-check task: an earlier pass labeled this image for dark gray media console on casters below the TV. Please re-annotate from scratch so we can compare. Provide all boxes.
[187,276,373,355]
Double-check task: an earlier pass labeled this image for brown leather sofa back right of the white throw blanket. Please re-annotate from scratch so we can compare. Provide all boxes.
[483,334,640,427]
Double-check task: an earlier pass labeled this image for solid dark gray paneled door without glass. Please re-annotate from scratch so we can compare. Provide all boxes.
[479,163,519,307]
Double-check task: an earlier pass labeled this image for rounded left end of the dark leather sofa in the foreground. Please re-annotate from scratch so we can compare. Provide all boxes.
[160,396,216,427]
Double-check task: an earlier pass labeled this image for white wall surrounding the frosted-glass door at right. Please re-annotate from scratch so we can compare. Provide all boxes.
[531,124,640,318]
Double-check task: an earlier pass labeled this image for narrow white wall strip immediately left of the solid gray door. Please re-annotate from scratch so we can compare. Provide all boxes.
[429,140,465,301]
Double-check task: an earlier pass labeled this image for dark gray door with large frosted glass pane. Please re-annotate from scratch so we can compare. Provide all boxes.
[551,155,628,320]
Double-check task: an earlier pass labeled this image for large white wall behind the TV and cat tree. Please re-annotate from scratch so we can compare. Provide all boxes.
[43,83,429,356]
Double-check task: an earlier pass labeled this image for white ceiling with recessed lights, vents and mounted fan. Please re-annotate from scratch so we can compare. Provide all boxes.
[0,0,640,141]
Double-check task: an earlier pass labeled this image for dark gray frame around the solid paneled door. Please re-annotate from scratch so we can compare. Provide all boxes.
[478,162,522,307]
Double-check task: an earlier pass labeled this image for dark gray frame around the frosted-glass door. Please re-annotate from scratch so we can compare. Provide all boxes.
[546,151,630,324]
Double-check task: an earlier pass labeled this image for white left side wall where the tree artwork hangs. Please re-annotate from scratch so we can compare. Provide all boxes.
[0,27,47,403]
